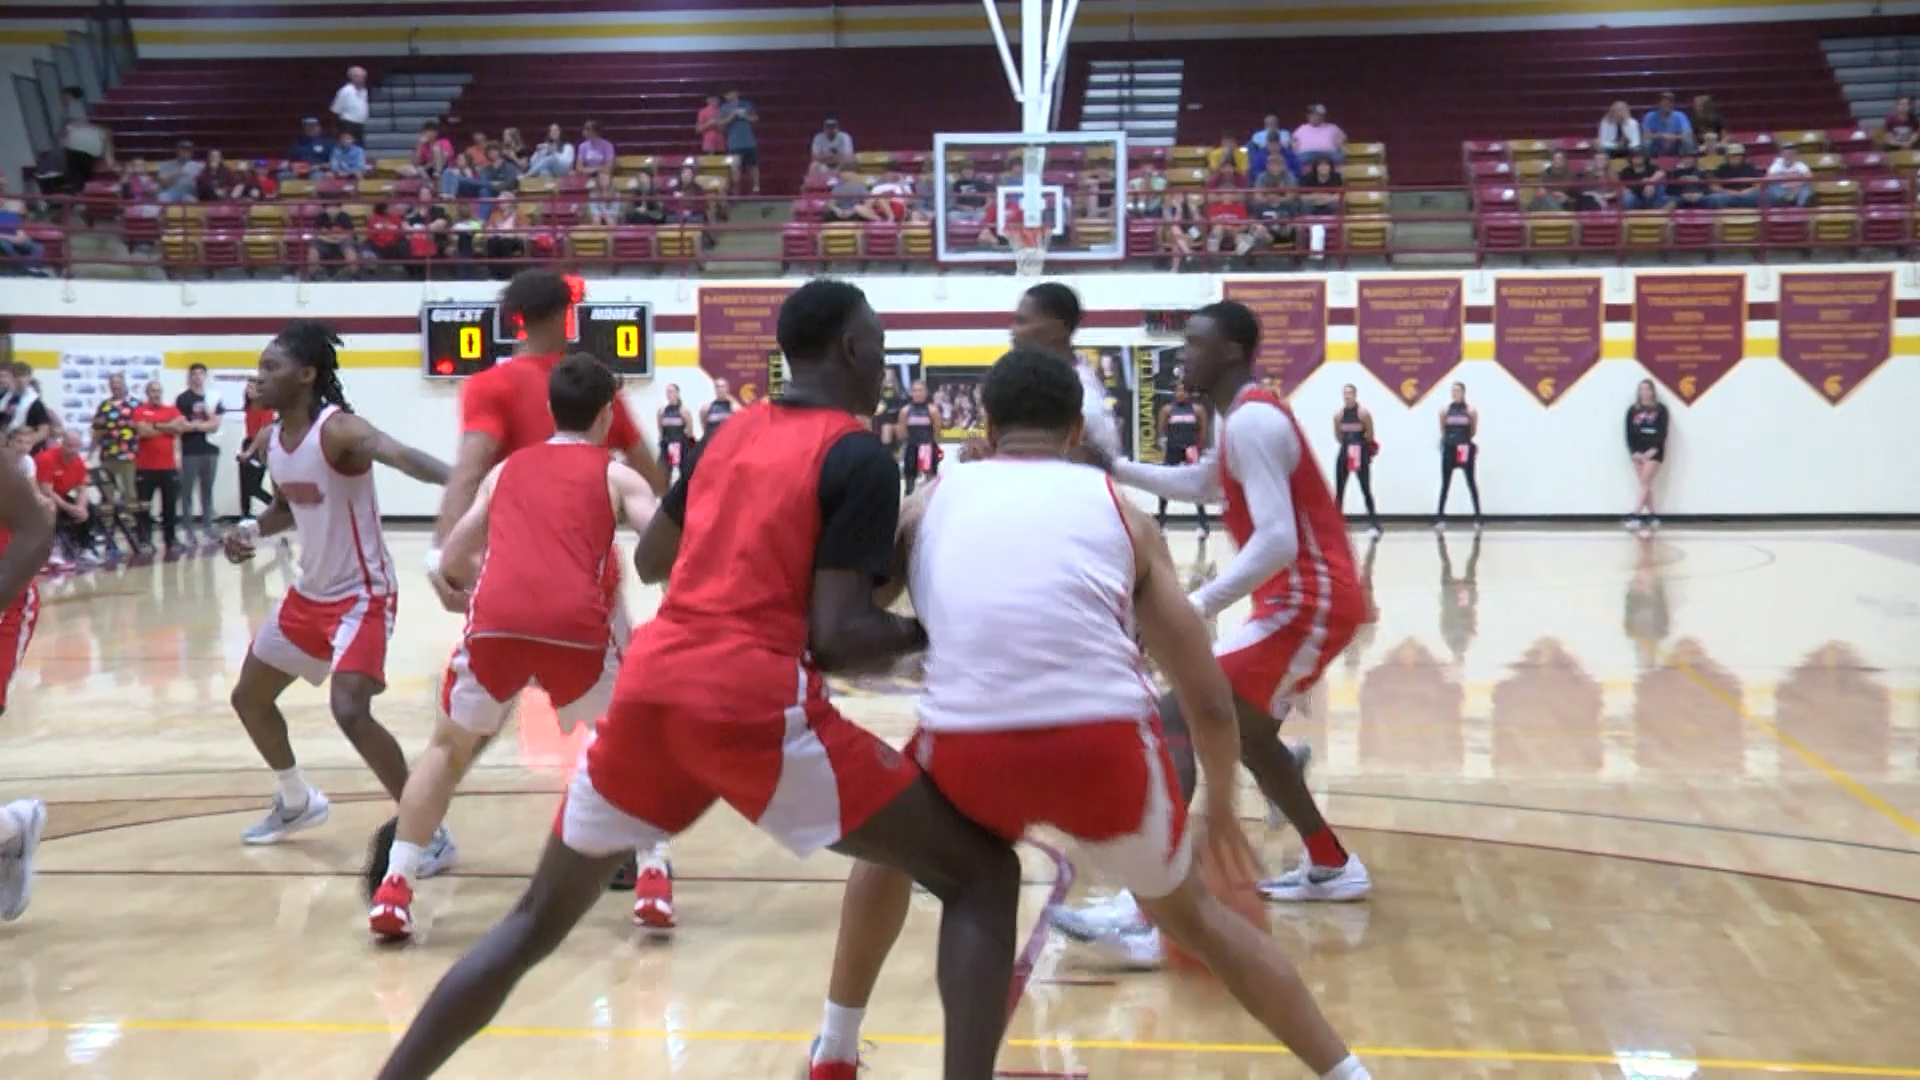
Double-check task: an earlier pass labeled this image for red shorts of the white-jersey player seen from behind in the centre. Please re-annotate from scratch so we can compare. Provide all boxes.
[908,717,1192,897]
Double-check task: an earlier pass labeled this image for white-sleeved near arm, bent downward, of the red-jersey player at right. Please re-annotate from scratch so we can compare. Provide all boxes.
[1188,402,1300,617]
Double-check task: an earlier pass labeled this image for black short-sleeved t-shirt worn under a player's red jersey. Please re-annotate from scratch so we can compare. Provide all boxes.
[660,400,900,580]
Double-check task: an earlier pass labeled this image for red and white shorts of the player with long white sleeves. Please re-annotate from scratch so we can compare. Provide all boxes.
[1213,600,1367,717]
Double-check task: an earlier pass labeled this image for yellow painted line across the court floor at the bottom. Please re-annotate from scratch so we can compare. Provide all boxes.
[0,1020,1920,1078]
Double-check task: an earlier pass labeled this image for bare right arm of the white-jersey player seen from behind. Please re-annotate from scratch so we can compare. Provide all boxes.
[1119,502,1240,817]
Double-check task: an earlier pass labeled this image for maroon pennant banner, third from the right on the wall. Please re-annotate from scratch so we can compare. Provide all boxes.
[1494,277,1607,405]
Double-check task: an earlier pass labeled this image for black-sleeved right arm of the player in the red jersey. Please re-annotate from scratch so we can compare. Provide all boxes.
[806,430,927,671]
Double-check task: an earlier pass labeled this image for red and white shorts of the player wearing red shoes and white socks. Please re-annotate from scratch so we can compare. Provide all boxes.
[440,636,620,736]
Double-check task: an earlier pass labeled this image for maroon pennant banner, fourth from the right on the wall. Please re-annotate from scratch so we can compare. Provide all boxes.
[1354,277,1465,405]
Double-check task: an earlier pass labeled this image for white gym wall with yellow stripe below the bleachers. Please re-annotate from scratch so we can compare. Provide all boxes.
[11,267,1920,517]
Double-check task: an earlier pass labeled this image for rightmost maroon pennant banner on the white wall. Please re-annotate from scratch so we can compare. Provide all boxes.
[1780,273,1893,405]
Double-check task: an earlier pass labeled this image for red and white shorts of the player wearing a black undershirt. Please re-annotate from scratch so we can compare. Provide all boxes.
[557,696,920,855]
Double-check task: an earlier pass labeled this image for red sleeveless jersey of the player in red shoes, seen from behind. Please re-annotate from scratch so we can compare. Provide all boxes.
[467,438,614,648]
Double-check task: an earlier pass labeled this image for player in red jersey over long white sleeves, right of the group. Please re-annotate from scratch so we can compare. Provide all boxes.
[1052,300,1373,967]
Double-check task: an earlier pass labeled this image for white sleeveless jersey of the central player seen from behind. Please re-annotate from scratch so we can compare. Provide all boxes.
[910,459,1156,730]
